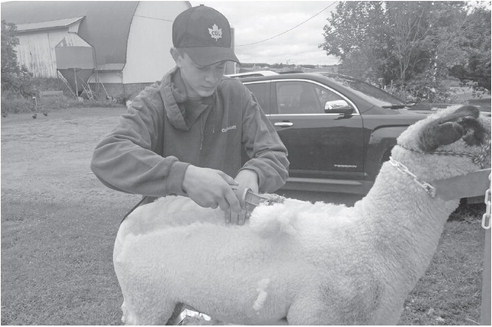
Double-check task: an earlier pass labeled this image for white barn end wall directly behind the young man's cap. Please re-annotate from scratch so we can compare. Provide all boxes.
[123,1,189,84]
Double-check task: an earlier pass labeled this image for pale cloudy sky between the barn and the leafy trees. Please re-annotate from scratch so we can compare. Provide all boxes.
[190,0,338,65]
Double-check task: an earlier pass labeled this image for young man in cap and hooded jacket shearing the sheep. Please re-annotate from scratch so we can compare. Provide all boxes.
[91,5,289,224]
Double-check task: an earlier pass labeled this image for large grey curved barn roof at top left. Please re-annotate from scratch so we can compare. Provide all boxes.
[1,1,138,66]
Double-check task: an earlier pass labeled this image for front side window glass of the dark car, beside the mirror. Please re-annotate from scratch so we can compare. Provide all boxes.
[276,81,343,114]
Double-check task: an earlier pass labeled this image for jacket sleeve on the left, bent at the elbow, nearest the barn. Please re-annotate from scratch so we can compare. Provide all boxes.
[91,87,188,197]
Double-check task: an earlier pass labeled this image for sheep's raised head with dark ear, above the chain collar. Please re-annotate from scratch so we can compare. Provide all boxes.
[392,106,491,180]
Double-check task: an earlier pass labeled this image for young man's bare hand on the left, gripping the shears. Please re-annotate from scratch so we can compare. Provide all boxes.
[183,165,241,224]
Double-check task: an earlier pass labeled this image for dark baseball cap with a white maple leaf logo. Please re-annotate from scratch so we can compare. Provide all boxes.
[173,5,239,66]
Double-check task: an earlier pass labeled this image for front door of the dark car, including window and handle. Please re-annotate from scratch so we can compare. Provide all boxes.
[268,79,364,180]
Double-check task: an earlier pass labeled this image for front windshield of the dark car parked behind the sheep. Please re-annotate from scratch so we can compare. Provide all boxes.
[321,73,405,106]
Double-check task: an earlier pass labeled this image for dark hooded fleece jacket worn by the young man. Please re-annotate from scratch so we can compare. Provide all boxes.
[91,68,289,197]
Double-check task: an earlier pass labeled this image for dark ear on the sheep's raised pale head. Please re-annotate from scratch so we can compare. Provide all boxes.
[418,106,488,153]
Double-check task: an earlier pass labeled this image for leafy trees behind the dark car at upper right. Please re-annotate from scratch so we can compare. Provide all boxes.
[320,1,490,101]
